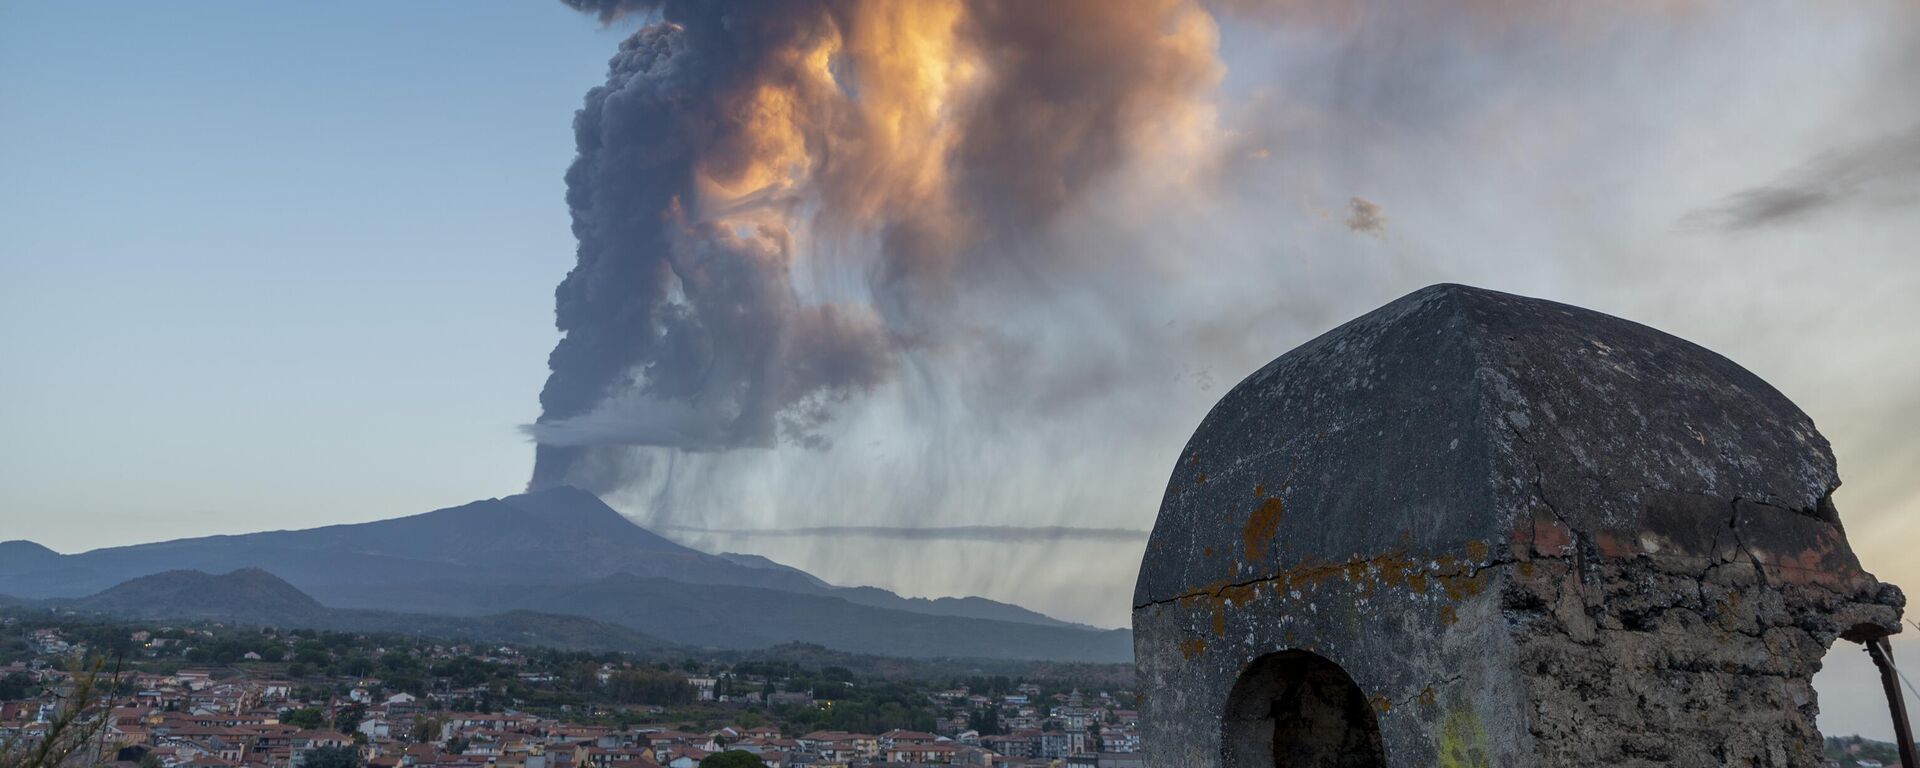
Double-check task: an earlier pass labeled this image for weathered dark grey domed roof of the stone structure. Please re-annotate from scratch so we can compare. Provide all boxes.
[1135,284,1870,607]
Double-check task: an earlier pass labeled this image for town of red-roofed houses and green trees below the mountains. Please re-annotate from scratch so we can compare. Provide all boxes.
[0,611,1142,768]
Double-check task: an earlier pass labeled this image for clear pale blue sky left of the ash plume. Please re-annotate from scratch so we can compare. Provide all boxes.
[0,2,645,551]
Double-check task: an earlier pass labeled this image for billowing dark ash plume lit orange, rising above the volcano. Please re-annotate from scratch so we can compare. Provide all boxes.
[526,0,1219,492]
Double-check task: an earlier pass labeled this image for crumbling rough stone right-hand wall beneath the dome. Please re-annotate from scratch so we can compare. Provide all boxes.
[1501,537,1903,768]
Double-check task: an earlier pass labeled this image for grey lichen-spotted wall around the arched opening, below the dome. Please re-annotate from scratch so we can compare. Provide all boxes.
[1135,547,1532,768]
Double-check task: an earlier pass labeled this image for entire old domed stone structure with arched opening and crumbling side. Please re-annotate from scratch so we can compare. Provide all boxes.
[1133,286,1905,768]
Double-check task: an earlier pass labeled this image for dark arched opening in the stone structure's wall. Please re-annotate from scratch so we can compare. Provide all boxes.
[1221,651,1386,768]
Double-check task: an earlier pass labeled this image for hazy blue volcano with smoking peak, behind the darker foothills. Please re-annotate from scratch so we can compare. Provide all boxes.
[0,486,1068,626]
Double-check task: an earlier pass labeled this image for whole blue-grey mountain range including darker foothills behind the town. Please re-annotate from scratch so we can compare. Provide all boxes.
[0,488,1131,662]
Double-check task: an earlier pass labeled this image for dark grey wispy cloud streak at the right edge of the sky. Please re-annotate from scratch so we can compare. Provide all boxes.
[1680,127,1920,232]
